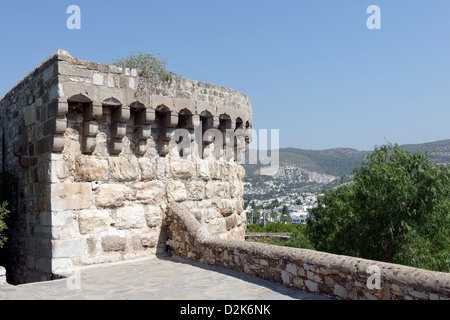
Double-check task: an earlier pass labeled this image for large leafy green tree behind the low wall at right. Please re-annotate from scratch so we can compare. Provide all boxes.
[307,144,450,272]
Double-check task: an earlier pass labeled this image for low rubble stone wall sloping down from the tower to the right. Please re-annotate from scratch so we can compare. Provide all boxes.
[169,203,450,300]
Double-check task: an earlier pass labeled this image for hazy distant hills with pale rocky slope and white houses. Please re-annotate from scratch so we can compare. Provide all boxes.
[244,139,450,198]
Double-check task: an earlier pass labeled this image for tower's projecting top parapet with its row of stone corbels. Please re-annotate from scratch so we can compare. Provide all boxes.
[53,55,252,160]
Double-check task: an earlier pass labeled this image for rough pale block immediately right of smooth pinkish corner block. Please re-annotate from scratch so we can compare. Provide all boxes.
[95,184,133,207]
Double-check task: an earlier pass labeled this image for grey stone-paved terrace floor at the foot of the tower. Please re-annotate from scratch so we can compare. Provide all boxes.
[0,256,329,300]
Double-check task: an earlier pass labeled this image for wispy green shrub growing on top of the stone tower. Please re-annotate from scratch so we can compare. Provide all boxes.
[114,51,178,82]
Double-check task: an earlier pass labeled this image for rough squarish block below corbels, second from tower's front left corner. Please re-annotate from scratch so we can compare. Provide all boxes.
[75,155,108,182]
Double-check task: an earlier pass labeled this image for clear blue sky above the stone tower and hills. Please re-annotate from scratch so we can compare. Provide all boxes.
[0,0,450,150]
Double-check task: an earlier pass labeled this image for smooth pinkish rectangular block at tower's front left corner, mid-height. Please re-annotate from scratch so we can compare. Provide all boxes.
[51,183,92,211]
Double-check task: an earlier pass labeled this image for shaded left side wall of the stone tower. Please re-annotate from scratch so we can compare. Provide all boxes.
[0,56,58,283]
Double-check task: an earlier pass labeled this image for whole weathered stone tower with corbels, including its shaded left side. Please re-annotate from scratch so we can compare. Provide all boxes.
[0,51,252,283]
